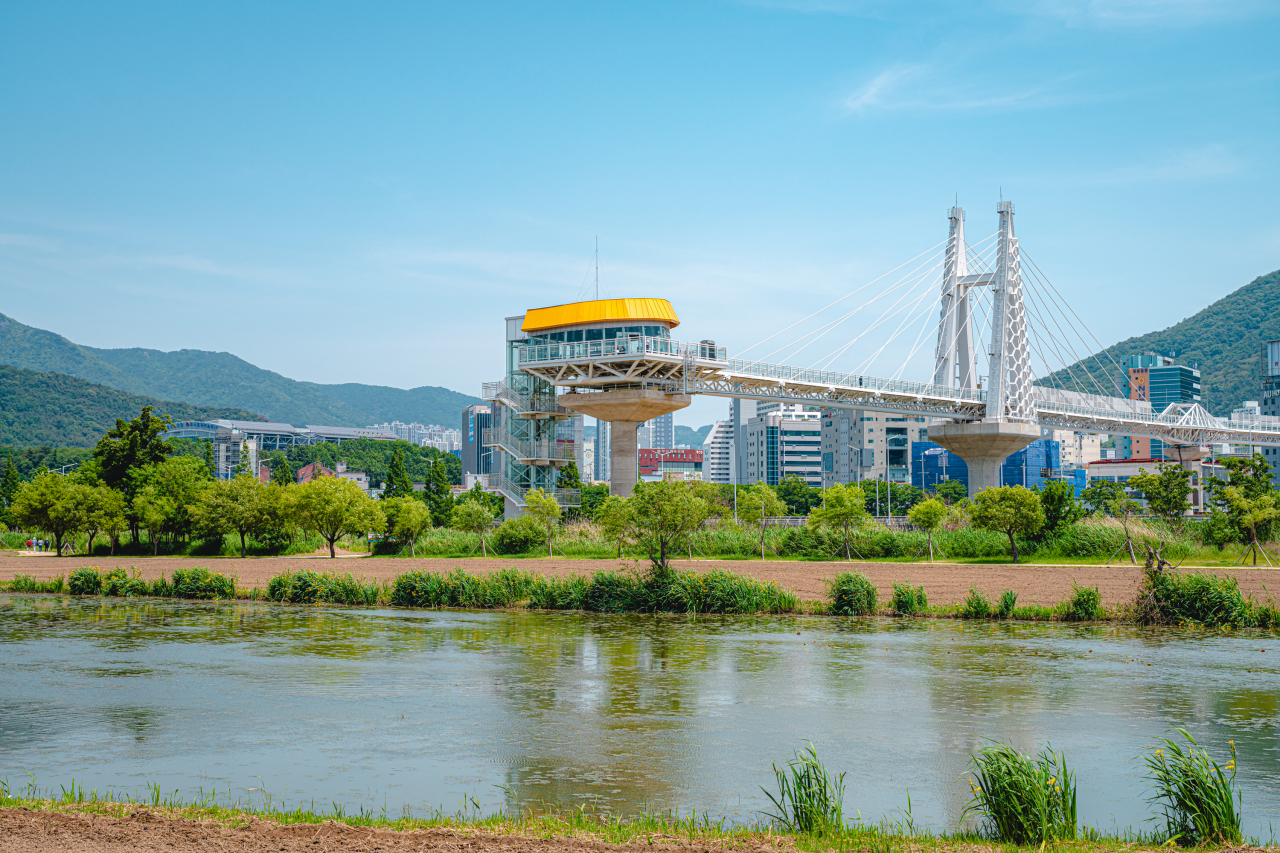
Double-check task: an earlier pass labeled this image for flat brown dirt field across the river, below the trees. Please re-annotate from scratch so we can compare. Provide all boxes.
[0,555,1280,606]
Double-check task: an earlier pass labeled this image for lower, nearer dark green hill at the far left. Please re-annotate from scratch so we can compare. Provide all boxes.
[0,365,264,447]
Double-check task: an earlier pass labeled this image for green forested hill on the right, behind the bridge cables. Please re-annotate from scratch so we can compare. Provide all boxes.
[1039,270,1280,418]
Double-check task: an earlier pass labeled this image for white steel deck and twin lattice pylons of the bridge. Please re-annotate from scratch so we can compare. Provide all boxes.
[518,201,1280,456]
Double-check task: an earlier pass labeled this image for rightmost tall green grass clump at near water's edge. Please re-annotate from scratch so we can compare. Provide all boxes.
[1147,729,1242,847]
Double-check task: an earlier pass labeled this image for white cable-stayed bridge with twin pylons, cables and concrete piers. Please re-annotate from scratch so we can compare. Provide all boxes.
[486,201,1280,493]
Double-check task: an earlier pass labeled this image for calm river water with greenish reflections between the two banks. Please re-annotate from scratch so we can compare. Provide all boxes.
[0,596,1280,840]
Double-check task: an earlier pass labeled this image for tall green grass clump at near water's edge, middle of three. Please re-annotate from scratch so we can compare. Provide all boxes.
[961,744,1075,847]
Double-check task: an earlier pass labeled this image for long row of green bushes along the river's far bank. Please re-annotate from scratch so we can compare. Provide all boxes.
[8,567,1280,629]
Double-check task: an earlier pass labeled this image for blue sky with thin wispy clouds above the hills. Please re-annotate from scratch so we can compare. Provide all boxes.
[0,0,1280,427]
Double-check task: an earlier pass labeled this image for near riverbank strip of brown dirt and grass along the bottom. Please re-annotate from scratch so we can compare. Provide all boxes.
[0,798,1259,853]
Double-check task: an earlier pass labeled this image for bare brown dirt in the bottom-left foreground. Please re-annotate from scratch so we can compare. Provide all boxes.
[0,808,781,853]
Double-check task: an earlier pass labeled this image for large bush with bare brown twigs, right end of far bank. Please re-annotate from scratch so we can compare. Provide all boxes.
[1134,569,1257,626]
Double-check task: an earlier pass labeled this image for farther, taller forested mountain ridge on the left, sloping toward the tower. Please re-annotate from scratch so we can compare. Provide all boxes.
[0,315,479,427]
